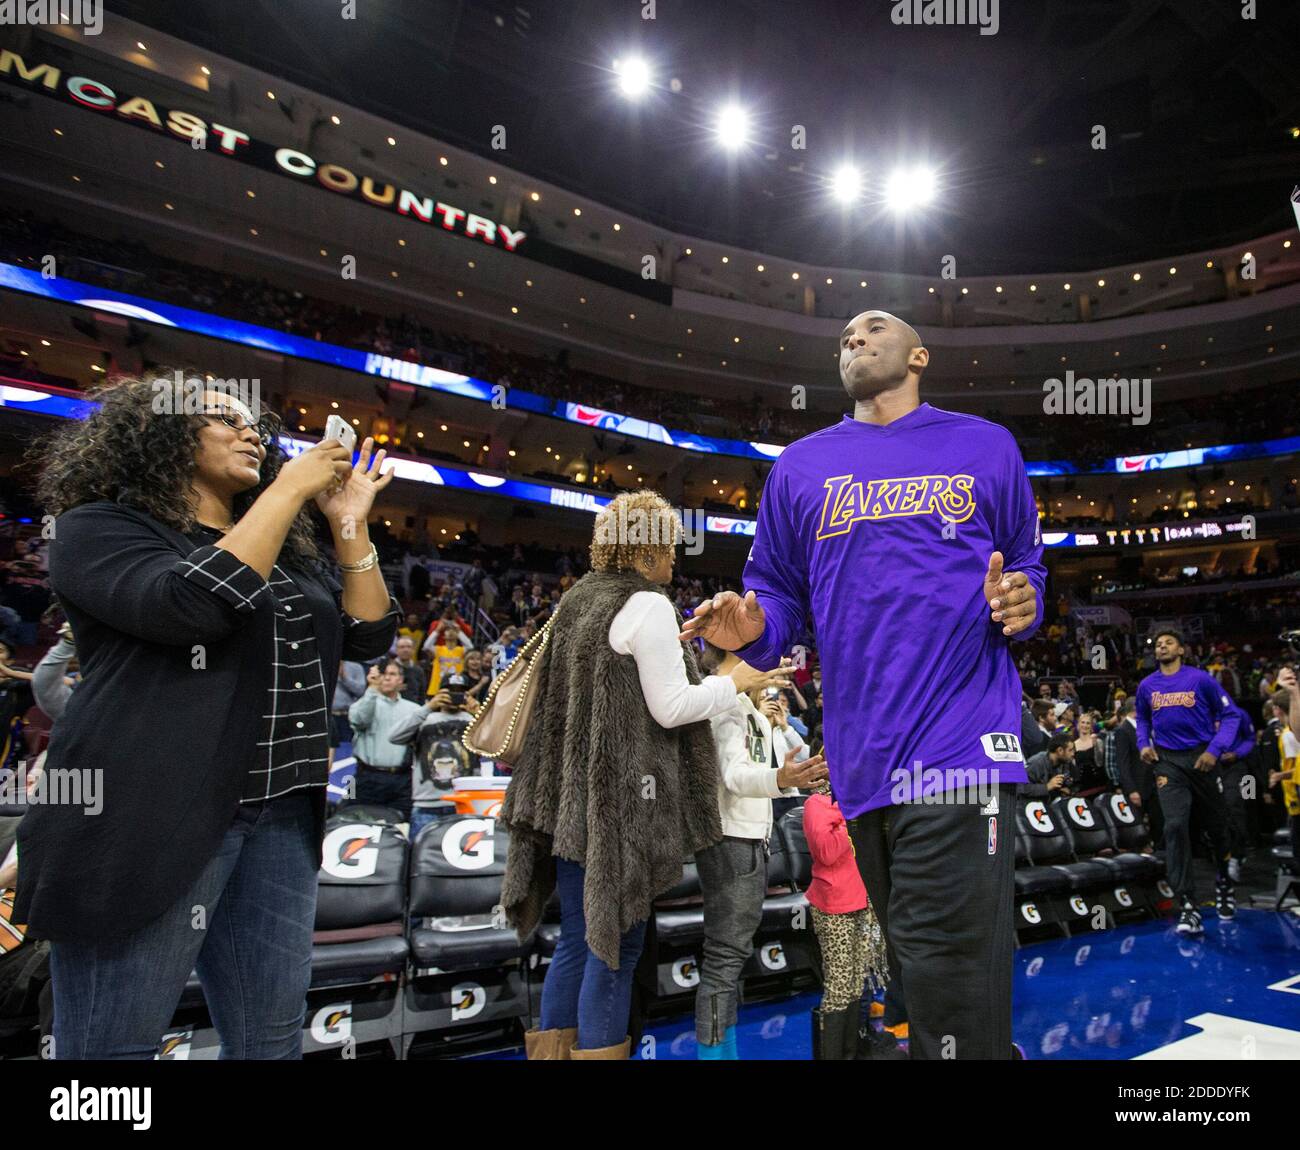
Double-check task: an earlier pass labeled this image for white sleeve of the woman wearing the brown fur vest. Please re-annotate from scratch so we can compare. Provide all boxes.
[610,591,736,728]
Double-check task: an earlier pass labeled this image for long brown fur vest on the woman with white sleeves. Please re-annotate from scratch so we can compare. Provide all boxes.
[501,572,723,969]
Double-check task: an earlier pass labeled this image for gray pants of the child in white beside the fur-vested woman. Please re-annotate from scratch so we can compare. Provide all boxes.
[696,838,767,1046]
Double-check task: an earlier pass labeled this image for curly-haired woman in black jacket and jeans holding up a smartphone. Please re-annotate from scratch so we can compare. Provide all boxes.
[14,379,399,1059]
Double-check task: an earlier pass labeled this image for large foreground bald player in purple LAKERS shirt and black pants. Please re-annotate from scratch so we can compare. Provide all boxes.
[683,311,1047,1059]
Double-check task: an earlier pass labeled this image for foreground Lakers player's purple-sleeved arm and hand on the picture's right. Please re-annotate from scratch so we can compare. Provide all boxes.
[984,434,1048,639]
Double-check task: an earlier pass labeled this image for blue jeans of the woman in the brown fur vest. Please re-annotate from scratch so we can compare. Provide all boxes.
[538,859,646,1050]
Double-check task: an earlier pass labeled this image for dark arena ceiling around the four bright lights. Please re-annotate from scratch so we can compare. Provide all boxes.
[108,0,1300,275]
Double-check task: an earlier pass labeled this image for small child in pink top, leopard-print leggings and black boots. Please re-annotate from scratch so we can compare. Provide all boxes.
[803,782,888,1059]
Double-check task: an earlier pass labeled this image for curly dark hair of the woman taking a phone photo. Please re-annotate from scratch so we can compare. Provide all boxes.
[29,368,321,568]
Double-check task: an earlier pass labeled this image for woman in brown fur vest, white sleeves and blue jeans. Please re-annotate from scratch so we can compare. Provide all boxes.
[501,491,759,1059]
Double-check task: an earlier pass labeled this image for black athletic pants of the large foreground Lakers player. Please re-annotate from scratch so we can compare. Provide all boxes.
[849,784,1015,1059]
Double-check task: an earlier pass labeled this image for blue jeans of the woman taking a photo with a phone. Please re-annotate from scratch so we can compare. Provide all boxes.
[49,791,320,1059]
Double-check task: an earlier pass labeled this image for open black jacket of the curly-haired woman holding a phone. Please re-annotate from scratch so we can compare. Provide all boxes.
[14,502,397,942]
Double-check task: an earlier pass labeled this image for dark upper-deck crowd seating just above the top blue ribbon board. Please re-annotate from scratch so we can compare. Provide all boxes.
[0,211,1300,468]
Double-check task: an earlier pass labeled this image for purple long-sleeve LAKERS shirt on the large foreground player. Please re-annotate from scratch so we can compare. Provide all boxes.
[736,403,1047,819]
